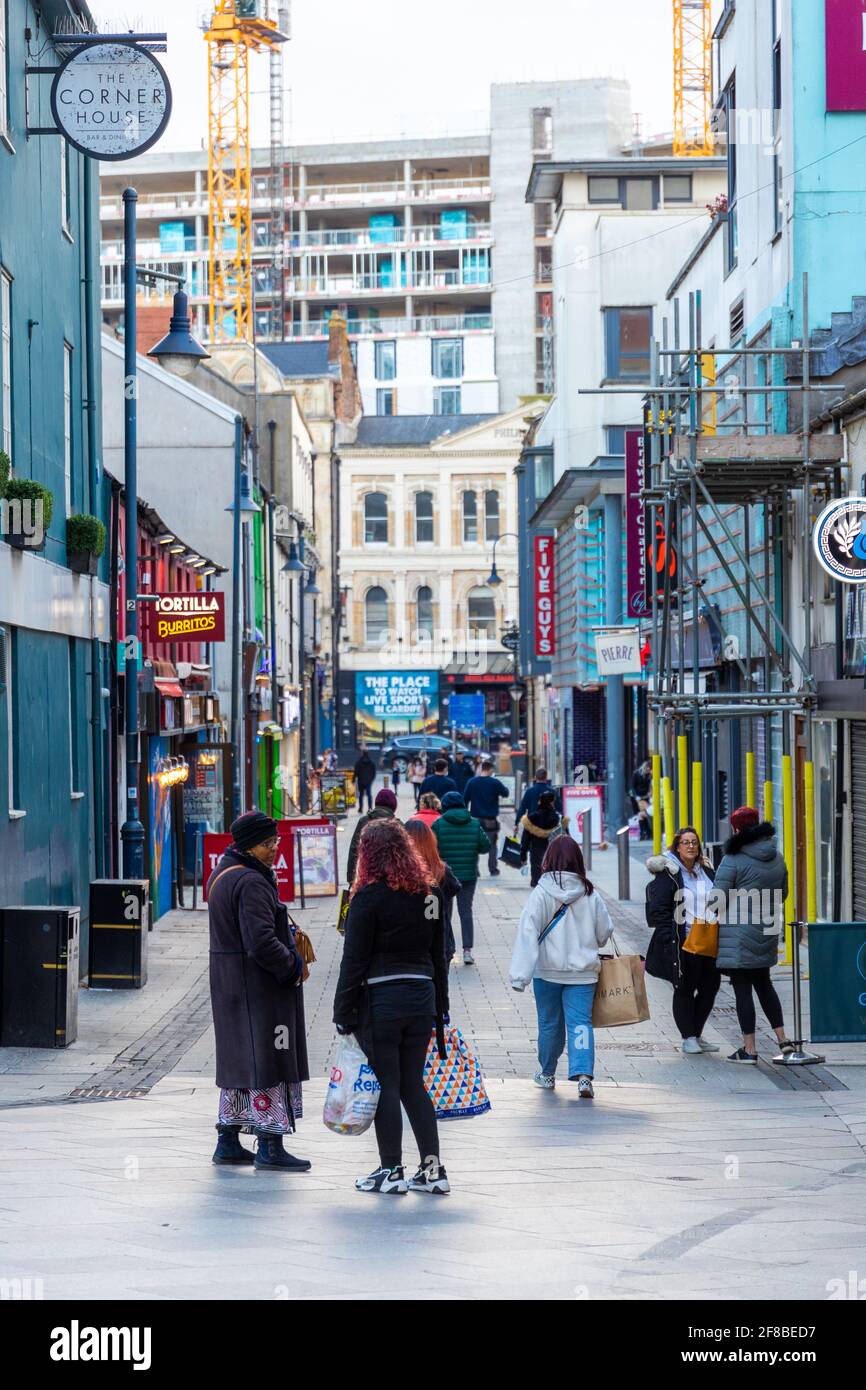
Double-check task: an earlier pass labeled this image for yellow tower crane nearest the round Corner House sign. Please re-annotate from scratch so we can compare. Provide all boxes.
[204,0,286,342]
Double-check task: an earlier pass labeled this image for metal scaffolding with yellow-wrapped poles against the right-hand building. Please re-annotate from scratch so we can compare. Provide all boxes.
[642,275,844,962]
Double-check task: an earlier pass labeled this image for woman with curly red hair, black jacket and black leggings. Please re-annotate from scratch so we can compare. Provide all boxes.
[334,819,449,1194]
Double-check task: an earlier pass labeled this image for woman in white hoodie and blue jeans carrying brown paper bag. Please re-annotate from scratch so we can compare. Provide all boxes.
[510,835,613,1101]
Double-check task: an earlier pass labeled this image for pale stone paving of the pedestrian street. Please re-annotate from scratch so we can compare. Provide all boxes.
[0,803,866,1300]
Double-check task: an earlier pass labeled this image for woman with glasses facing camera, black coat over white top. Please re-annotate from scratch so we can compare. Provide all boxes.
[646,826,721,1055]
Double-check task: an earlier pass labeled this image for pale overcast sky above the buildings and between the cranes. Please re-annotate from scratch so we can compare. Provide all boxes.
[90,0,673,149]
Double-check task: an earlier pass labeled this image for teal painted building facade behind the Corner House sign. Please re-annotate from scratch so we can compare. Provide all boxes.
[0,0,110,963]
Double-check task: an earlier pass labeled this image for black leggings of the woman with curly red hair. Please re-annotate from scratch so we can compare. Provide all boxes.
[373,1006,439,1168]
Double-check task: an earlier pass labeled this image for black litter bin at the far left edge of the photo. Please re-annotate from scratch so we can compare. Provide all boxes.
[0,906,81,1047]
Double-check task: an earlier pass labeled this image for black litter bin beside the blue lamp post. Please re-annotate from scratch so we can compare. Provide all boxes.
[88,878,149,990]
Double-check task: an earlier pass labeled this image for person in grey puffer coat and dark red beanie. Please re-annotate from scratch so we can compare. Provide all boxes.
[713,806,794,1066]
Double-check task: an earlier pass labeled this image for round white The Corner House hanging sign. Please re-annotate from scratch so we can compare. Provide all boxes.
[51,39,171,160]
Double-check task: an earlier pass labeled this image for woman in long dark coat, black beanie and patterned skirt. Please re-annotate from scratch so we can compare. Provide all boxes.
[207,810,311,1173]
